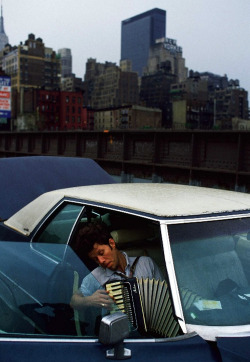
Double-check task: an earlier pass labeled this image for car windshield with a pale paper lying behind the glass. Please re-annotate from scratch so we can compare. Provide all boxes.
[169,218,250,326]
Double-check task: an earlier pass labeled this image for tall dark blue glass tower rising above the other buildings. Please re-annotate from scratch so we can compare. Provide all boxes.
[121,9,166,76]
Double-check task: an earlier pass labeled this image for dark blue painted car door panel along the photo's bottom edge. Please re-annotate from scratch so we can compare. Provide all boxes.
[0,336,220,362]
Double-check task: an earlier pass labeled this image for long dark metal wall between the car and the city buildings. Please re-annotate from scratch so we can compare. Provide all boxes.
[0,130,250,192]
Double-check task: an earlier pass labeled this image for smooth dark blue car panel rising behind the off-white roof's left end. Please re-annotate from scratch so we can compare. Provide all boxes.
[0,156,115,220]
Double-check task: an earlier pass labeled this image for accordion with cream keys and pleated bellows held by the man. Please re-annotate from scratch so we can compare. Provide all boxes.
[106,278,180,337]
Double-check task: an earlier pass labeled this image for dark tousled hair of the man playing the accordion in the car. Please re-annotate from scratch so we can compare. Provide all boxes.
[76,221,111,257]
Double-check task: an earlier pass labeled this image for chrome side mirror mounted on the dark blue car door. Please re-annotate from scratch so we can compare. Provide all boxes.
[99,312,131,359]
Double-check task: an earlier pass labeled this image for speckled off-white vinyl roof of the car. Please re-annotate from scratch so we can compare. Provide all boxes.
[5,183,250,235]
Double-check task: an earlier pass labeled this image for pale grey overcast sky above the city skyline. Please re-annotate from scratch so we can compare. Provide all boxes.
[1,0,250,98]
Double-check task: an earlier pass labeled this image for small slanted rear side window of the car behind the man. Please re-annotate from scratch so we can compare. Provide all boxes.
[32,204,82,261]
